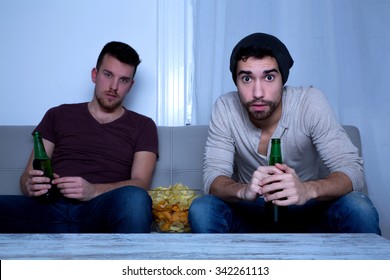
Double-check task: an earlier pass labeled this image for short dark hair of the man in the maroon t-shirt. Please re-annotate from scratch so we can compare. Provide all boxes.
[96,41,141,77]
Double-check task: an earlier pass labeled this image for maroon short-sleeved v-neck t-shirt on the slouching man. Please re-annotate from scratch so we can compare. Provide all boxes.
[35,103,158,183]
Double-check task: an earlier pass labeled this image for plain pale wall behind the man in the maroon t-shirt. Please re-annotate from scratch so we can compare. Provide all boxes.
[0,0,157,125]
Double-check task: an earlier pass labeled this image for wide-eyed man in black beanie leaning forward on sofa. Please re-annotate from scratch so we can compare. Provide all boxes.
[189,33,381,234]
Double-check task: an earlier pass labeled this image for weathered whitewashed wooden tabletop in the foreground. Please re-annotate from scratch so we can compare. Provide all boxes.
[0,233,390,260]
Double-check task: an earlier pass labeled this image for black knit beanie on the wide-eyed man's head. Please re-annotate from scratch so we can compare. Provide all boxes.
[230,33,294,85]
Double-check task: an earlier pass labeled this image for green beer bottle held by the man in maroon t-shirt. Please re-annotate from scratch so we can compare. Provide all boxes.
[33,131,60,203]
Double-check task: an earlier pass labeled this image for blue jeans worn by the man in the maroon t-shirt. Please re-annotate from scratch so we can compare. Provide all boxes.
[0,186,152,233]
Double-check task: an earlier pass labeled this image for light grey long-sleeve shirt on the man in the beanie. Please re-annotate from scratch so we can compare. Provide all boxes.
[203,86,365,193]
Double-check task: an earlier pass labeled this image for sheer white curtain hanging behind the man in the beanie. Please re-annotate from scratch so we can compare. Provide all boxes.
[192,0,390,238]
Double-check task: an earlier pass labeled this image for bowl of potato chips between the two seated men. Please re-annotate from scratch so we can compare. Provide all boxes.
[149,183,203,233]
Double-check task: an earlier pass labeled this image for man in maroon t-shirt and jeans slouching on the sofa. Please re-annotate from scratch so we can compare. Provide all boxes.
[0,42,158,232]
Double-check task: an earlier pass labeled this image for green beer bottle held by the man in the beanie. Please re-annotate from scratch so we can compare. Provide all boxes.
[265,138,287,231]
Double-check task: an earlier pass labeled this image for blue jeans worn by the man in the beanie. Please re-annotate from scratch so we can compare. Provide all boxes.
[189,192,381,235]
